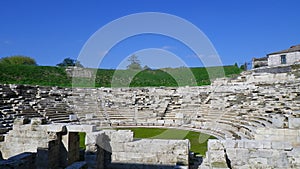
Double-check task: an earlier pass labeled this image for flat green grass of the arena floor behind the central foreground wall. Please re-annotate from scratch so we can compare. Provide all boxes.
[118,128,216,156]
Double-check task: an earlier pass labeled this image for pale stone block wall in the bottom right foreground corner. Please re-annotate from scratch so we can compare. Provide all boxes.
[199,140,300,169]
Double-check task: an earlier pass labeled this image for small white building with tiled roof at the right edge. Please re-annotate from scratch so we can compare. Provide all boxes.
[267,45,300,66]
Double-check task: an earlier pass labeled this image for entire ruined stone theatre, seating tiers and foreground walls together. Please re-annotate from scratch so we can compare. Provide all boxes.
[0,65,300,169]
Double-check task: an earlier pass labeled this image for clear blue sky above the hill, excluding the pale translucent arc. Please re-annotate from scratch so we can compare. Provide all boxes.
[0,0,300,68]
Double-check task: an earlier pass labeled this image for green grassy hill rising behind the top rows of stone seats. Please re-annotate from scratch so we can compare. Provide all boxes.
[0,64,241,87]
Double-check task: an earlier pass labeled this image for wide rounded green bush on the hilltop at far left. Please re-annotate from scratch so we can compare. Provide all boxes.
[0,55,37,65]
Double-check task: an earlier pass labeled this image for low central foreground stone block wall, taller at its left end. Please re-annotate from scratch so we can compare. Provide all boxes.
[86,130,190,169]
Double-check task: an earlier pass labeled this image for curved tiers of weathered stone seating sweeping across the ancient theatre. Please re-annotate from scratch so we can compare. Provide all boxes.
[0,68,300,139]
